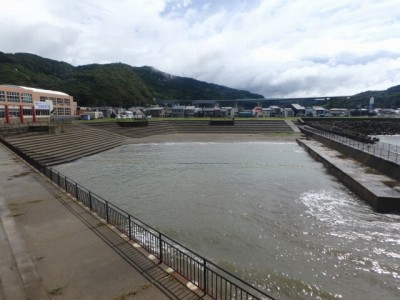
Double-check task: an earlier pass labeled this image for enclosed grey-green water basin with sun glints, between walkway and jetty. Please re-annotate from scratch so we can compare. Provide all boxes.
[57,142,400,299]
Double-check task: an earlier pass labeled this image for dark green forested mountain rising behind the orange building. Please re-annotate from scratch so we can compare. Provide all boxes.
[0,52,263,107]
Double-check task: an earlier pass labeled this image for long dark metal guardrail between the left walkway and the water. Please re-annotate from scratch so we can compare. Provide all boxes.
[0,138,275,300]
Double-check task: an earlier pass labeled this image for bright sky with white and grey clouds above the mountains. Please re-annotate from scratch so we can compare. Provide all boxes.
[0,0,400,98]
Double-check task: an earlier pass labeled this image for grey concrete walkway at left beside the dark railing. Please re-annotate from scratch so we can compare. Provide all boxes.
[0,144,199,300]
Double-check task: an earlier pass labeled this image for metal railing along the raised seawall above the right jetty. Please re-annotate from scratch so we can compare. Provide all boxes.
[302,126,400,164]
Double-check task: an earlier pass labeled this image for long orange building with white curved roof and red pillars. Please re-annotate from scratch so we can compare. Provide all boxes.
[0,85,76,124]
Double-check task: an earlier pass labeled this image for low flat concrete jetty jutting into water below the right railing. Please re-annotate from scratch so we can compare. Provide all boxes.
[297,139,400,213]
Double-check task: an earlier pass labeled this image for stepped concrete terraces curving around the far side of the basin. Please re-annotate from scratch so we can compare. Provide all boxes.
[5,120,297,166]
